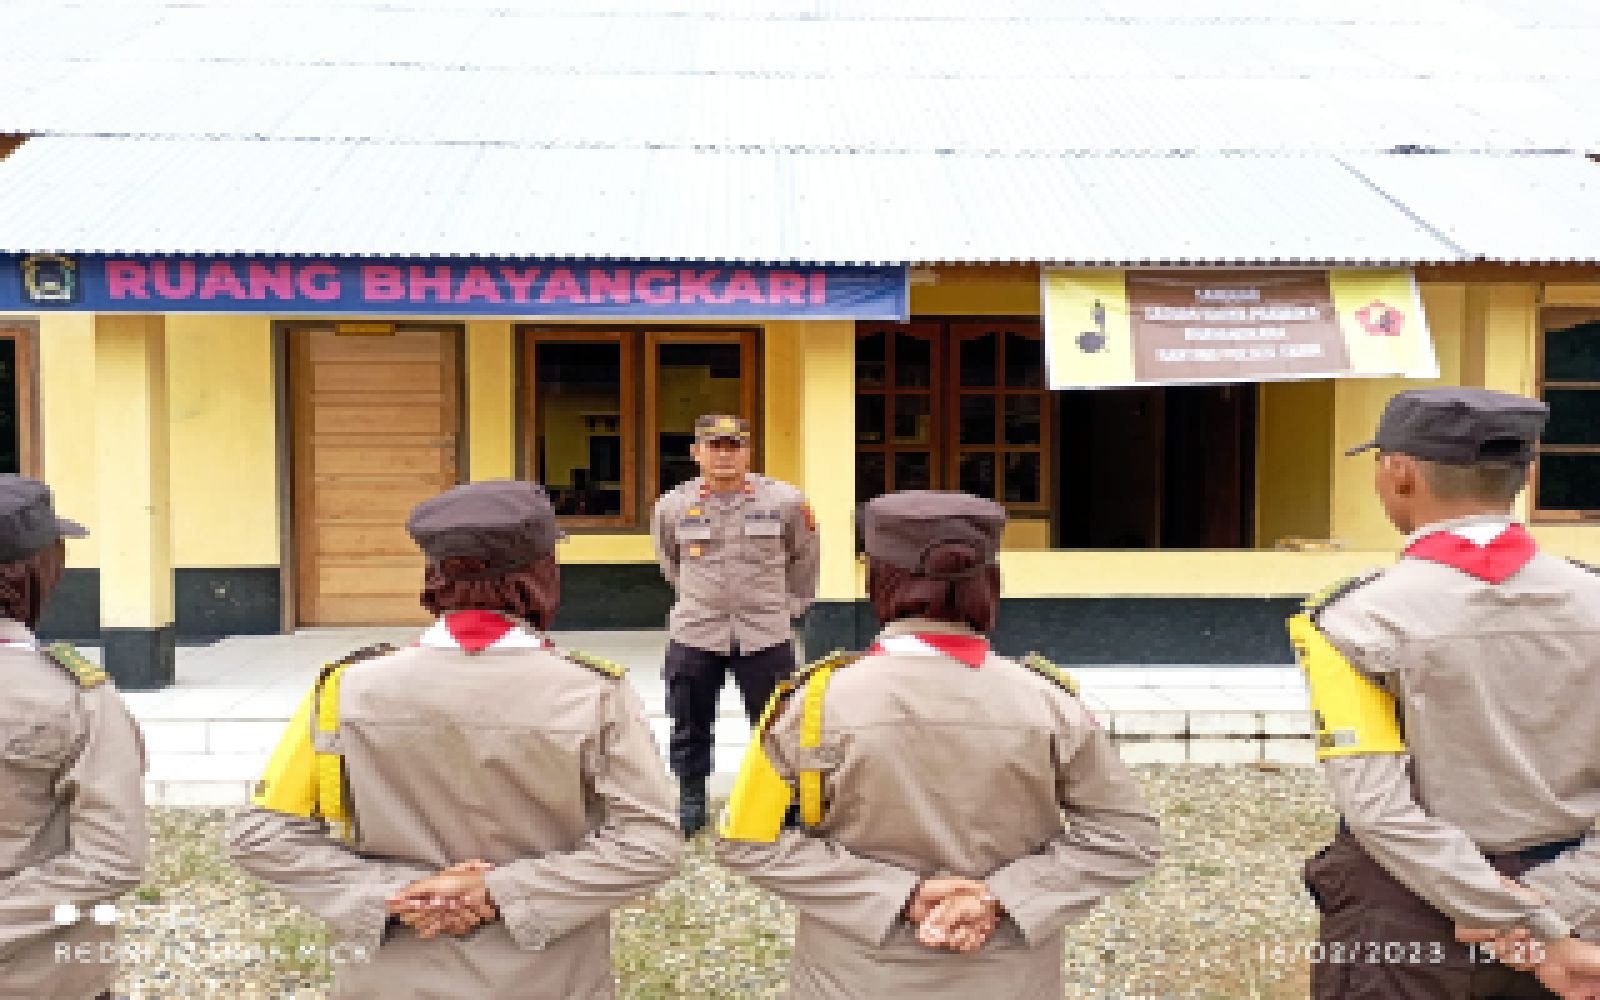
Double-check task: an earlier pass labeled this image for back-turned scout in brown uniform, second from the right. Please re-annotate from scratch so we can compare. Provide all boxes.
[717,491,1160,1000]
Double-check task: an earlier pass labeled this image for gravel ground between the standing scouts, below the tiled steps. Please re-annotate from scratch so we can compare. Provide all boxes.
[117,765,1333,1000]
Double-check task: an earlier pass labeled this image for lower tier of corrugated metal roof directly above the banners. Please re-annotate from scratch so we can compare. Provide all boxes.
[0,138,1555,262]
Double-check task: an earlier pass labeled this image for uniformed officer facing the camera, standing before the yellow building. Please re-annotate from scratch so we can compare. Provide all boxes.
[651,414,819,837]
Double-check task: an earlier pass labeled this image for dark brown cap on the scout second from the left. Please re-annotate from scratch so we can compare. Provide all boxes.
[405,480,563,576]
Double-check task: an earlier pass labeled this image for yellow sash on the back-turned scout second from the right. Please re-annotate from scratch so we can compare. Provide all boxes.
[717,653,859,843]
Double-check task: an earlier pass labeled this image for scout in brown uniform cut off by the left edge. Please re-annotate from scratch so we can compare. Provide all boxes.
[0,475,146,1000]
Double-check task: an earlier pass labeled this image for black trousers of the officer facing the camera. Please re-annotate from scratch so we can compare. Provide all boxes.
[666,642,795,778]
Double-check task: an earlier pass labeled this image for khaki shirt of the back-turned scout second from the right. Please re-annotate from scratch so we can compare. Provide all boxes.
[717,619,1160,1000]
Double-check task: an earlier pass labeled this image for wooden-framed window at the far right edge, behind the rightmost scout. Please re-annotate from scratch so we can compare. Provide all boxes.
[1533,309,1600,522]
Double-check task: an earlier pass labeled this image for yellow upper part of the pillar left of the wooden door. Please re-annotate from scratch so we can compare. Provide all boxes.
[166,314,282,566]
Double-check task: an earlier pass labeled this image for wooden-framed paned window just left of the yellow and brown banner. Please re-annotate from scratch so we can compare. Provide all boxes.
[856,318,1051,514]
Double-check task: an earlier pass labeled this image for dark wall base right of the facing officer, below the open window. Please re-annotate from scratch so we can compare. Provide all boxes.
[805,597,1299,666]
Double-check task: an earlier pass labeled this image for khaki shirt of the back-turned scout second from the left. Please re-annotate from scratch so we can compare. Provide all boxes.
[229,627,682,1000]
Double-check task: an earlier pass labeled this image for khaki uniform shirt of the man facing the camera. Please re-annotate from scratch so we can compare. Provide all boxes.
[651,474,821,653]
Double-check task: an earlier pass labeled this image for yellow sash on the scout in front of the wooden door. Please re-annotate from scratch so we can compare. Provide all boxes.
[250,643,395,840]
